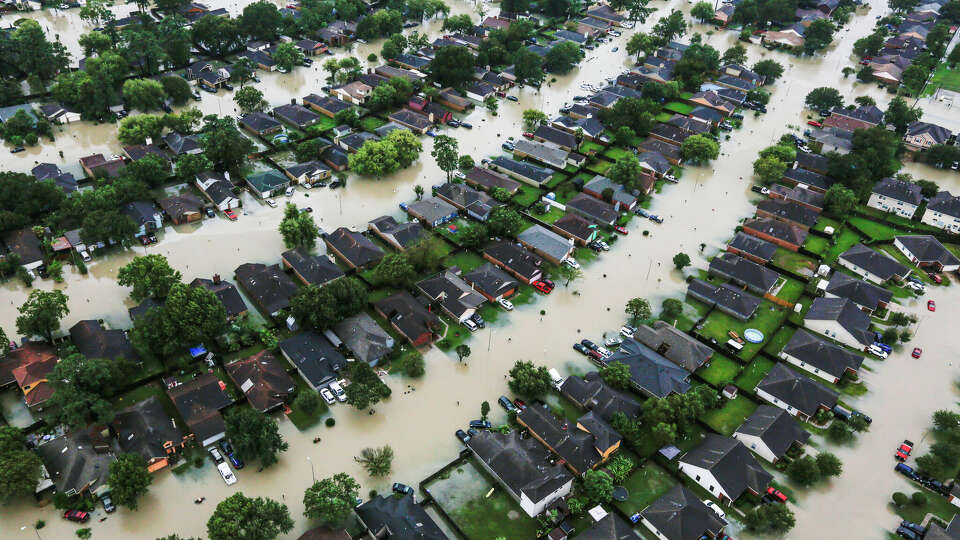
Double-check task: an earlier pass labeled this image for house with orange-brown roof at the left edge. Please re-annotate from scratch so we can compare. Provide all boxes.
[7,342,60,410]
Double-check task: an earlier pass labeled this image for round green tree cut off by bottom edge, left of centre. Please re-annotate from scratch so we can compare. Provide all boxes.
[201,494,293,540]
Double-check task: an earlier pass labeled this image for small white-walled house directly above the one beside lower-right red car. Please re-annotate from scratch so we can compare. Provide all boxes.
[733,405,810,463]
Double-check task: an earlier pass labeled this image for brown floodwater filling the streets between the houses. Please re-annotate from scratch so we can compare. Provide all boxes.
[0,0,960,539]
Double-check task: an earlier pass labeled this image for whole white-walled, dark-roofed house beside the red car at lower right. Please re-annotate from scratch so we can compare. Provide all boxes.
[678,433,773,504]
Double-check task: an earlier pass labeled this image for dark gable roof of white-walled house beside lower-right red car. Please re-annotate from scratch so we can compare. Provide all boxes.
[680,432,782,500]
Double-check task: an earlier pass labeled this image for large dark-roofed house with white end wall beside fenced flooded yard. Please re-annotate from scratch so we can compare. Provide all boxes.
[466,430,573,517]
